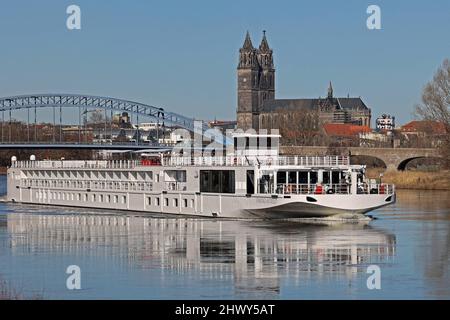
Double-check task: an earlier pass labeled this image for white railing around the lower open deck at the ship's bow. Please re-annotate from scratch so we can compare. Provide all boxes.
[266,183,395,195]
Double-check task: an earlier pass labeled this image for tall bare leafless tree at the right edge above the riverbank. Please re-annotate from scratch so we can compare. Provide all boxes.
[415,59,450,166]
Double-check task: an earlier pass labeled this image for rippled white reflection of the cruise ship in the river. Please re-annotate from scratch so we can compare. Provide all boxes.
[7,212,396,298]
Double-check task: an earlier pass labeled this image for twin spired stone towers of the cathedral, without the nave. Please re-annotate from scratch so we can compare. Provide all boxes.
[237,31,275,130]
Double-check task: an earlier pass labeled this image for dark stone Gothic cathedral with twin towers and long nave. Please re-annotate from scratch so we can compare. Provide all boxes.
[237,31,371,130]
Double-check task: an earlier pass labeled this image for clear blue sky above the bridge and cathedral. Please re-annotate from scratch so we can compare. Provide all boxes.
[0,0,450,124]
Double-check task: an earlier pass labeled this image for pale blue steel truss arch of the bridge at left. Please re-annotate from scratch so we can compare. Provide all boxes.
[0,94,202,131]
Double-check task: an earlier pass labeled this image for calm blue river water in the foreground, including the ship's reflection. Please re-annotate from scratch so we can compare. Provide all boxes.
[0,177,450,299]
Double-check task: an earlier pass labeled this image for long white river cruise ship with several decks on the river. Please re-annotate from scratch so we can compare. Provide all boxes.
[7,135,395,219]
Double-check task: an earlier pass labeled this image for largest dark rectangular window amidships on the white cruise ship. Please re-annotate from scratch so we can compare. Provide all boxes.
[200,170,235,193]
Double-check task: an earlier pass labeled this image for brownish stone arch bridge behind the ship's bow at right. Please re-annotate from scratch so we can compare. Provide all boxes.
[280,146,441,170]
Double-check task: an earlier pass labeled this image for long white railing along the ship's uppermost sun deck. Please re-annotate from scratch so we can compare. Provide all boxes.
[11,156,350,169]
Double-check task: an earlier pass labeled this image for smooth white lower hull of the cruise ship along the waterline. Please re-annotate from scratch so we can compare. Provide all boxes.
[8,194,395,219]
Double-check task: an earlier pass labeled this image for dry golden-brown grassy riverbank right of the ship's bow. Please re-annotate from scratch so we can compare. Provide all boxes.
[367,168,450,190]
